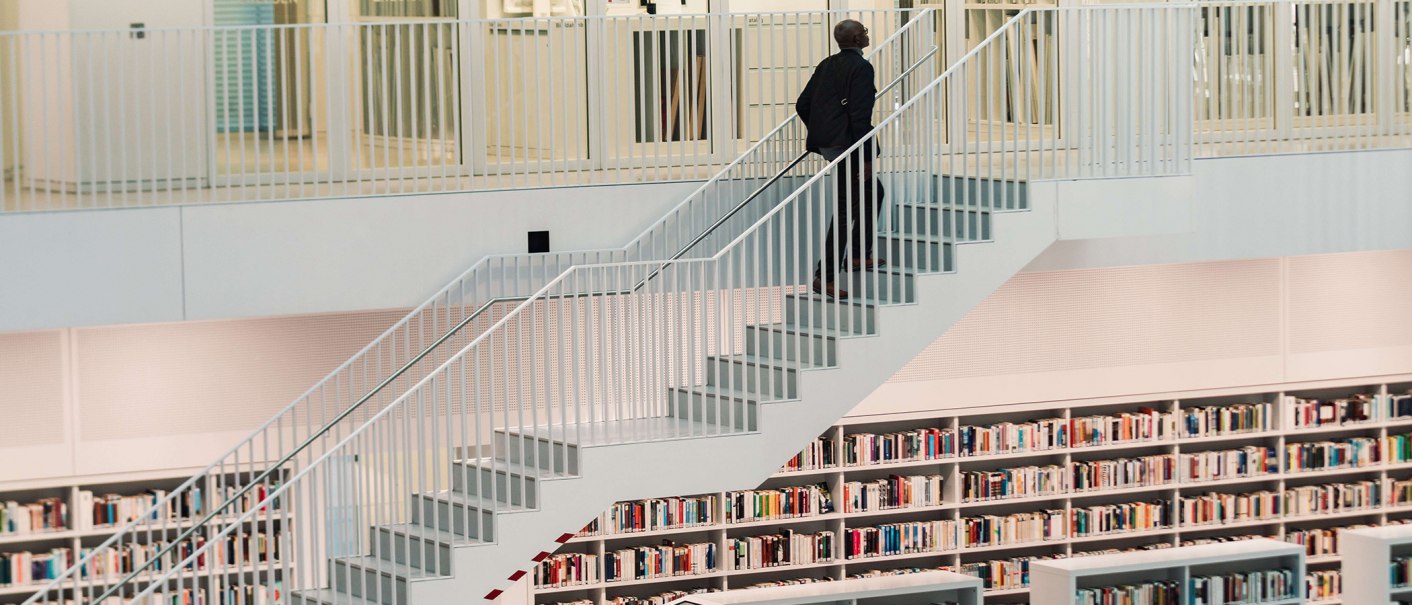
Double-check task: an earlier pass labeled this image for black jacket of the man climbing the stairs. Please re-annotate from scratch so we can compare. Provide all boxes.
[795,48,877,155]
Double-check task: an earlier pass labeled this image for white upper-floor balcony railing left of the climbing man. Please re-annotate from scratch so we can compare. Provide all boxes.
[0,10,915,212]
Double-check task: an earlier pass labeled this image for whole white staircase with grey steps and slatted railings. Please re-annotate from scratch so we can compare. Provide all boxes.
[19,7,1189,605]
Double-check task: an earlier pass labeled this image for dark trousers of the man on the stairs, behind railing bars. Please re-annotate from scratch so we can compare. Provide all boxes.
[813,158,884,284]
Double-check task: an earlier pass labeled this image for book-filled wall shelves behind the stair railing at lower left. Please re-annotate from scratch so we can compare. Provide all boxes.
[0,469,292,604]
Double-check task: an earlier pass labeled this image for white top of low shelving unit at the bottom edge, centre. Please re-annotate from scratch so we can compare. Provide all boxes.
[681,571,983,605]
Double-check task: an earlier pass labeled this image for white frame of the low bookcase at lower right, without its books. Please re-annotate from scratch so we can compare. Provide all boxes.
[1029,539,1305,605]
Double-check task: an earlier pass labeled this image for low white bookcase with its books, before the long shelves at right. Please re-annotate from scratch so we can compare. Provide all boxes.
[1029,539,1305,605]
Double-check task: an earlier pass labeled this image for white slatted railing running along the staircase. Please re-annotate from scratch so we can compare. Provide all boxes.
[28,6,1196,605]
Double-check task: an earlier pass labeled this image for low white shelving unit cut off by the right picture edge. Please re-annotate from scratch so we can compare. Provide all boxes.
[1339,526,1412,605]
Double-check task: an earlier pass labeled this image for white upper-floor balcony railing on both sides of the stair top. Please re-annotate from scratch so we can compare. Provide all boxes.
[0,0,1412,212]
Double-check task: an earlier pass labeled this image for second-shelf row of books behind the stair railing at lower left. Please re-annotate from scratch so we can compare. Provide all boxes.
[79,531,285,578]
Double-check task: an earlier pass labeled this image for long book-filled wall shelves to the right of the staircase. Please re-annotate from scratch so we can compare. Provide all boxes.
[528,377,1412,605]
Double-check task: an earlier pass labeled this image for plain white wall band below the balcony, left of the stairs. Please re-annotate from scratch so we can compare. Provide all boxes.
[0,182,699,332]
